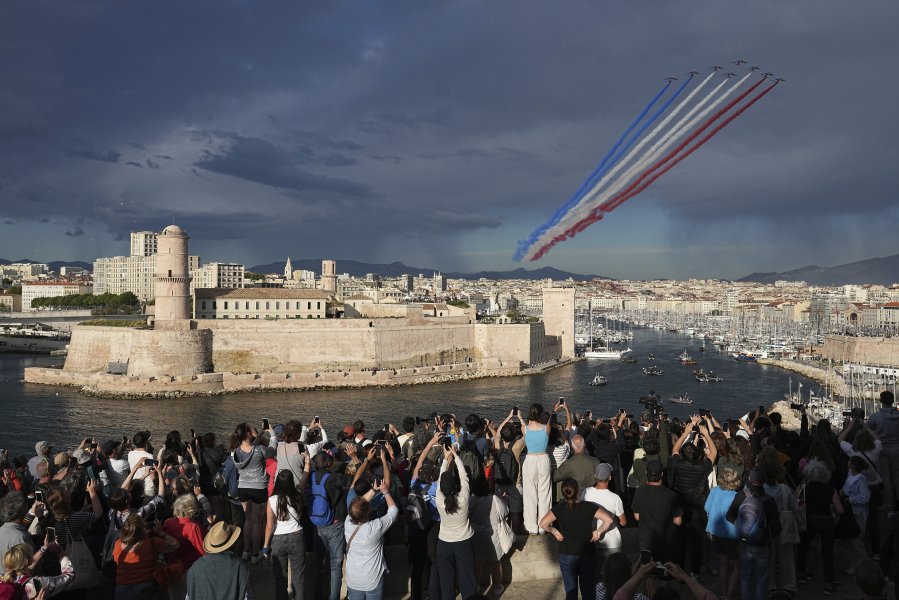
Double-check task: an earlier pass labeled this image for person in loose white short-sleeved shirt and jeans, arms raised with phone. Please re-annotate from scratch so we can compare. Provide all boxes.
[343,480,400,600]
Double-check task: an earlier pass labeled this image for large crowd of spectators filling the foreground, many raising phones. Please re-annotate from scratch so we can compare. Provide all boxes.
[0,392,899,600]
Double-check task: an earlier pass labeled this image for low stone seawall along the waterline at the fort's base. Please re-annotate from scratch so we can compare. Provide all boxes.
[25,360,584,398]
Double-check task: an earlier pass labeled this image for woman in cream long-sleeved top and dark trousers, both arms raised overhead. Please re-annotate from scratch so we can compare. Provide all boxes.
[436,446,477,598]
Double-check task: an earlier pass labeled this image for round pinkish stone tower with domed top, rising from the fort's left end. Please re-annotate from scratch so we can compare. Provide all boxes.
[155,225,190,322]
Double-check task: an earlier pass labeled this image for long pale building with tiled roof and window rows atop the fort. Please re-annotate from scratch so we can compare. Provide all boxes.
[194,288,329,320]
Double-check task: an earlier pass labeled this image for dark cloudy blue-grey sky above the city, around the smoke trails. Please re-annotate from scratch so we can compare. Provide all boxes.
[0,0,899,279]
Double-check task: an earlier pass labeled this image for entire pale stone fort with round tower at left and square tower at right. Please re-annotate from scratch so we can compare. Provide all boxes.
[25,225,574,395]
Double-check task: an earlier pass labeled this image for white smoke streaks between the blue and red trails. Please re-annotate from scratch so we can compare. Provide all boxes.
[525,71,752,260]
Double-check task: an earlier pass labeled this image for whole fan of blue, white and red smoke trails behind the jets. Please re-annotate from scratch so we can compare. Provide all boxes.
[515,63,782,260]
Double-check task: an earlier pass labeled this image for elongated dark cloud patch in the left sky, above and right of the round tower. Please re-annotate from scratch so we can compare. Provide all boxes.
[195,133,373,197]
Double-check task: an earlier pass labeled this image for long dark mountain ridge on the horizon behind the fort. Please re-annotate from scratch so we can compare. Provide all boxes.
[247,259,599,281]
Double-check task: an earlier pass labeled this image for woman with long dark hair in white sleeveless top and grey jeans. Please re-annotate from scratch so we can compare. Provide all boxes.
[262,468,309,600]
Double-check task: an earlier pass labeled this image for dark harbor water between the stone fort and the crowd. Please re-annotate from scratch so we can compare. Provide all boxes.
[0,328,819,455]
